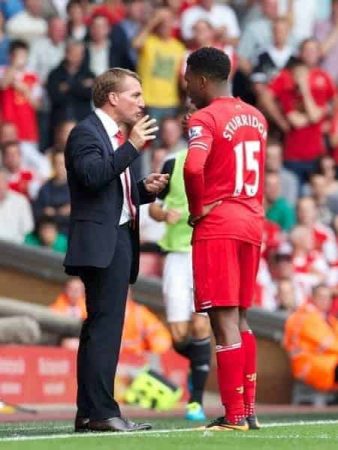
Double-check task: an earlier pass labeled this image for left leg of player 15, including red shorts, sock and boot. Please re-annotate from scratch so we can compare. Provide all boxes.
[193,239,248,431]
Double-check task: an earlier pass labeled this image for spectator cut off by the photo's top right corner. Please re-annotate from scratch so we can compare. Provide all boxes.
[314,0,338,84]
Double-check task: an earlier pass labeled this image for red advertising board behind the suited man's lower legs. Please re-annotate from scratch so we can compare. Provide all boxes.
[0,346,188,405]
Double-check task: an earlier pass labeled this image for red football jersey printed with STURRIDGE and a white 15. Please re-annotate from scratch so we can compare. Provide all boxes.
[184,97,267,245]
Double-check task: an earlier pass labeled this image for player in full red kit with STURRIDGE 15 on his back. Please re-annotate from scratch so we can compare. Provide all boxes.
[184,47,267,431]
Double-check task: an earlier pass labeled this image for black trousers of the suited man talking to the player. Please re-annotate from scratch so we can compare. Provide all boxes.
[77,227,132,420]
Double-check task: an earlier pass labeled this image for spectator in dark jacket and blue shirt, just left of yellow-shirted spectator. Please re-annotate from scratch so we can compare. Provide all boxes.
[111,0,147,71]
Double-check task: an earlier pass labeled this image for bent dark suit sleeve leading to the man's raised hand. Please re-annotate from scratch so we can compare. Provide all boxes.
[66,127,139,191]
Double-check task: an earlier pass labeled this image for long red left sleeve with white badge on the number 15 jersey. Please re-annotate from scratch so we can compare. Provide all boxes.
[184,111,215,216]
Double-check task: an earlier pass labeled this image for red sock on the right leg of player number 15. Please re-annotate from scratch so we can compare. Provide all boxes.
[241,330,257,417]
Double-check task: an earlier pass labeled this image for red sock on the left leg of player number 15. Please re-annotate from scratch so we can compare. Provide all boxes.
[216,342,245,424]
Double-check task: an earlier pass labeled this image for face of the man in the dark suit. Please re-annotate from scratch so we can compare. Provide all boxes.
[109,76,145,125]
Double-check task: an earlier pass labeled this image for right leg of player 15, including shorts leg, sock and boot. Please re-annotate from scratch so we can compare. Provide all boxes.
[239,243,260,430]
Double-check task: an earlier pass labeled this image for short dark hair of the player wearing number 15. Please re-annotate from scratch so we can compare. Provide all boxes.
[187,47,231,81]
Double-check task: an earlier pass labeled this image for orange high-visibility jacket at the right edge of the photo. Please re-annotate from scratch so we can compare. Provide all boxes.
[284,302,338,391]
